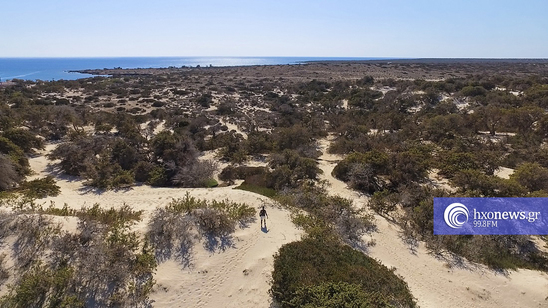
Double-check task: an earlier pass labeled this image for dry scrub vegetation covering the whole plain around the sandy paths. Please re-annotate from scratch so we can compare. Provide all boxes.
[0,60,548,306]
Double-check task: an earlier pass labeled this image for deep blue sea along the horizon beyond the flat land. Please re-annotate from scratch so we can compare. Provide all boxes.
[0,57,390,82]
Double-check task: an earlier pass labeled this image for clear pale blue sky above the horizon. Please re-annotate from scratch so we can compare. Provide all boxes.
[0,0,548,58]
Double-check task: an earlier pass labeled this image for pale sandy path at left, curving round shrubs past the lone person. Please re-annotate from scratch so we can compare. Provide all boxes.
[23,144,302,307]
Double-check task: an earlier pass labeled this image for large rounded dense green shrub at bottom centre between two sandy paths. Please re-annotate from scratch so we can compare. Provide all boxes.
[270,238,416,307]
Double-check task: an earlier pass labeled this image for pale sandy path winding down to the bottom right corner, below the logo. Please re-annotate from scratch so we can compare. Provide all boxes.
[319,139,548,308]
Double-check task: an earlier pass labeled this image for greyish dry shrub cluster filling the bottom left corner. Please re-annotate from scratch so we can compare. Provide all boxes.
[0,208,156,307]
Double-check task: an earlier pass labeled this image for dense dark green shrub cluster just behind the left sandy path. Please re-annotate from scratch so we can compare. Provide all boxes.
[48,129,216,189]
